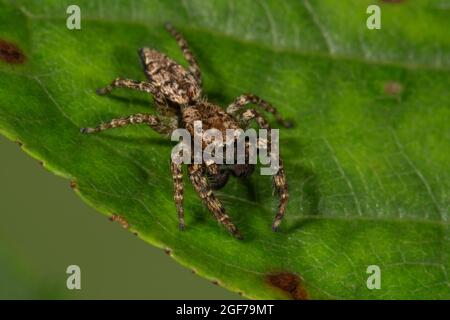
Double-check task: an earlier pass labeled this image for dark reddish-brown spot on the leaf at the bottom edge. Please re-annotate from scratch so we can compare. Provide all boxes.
[266,272,308,300]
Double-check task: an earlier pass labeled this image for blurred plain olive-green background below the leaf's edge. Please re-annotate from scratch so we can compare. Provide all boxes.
[0,136,240,299]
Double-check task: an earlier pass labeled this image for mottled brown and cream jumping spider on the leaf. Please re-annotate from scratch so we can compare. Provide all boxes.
[81,24,290,239]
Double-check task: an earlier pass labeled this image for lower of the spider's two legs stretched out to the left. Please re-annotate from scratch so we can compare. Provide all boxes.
[80,113,176,134]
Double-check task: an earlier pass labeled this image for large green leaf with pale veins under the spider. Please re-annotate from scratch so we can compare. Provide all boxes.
[0,0,450,299]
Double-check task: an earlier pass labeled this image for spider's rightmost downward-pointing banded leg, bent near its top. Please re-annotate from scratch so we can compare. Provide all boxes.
[242,109,289,231]
